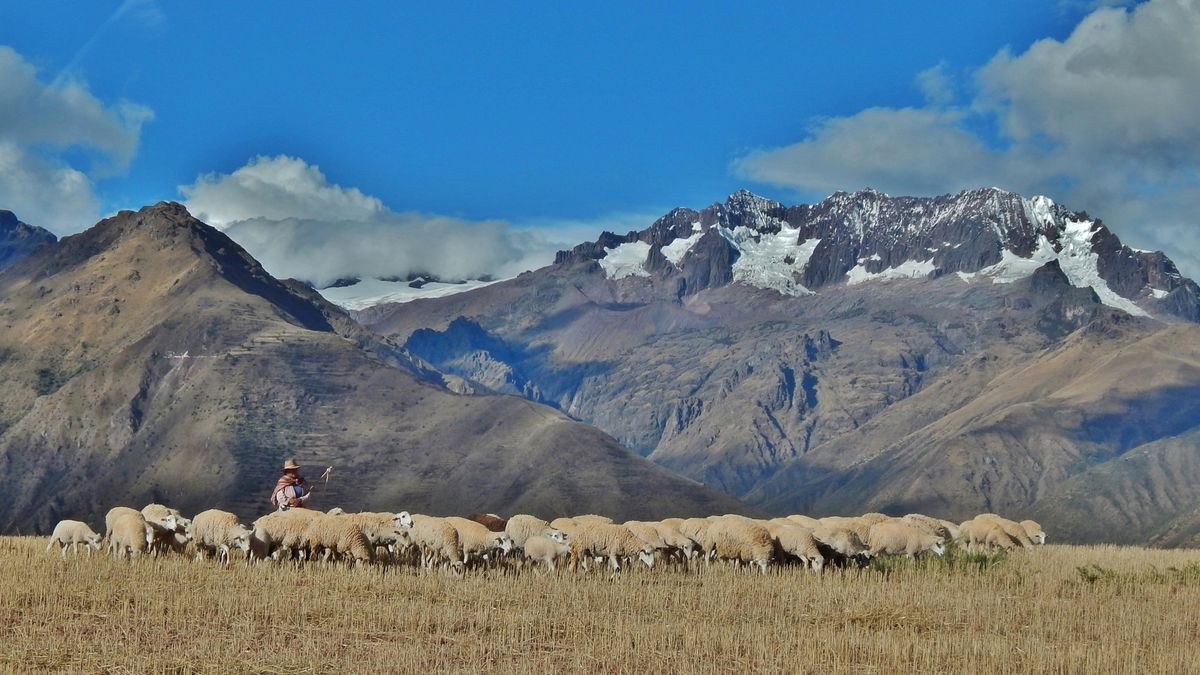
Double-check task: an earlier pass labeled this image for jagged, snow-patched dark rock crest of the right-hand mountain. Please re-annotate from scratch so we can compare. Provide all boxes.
[556,187,1200,321]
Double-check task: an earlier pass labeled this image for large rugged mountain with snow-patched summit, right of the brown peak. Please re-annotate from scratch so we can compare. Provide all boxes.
[356,190,1200,540]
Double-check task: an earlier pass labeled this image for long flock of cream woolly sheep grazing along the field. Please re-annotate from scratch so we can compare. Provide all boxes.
[47,504,1045,573]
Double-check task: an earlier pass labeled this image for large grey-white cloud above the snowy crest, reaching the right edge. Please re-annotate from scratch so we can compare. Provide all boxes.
[733,0,1200,276]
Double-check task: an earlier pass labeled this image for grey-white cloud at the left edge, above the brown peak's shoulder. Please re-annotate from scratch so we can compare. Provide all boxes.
[0,46,154,233]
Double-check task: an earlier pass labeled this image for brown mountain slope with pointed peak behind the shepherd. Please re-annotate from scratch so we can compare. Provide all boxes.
[0,203,744,532]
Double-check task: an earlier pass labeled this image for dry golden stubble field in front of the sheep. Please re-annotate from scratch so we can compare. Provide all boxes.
[0,537,1200,673]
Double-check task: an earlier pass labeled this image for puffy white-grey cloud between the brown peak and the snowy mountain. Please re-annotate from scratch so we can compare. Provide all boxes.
[180,155,600,286]
